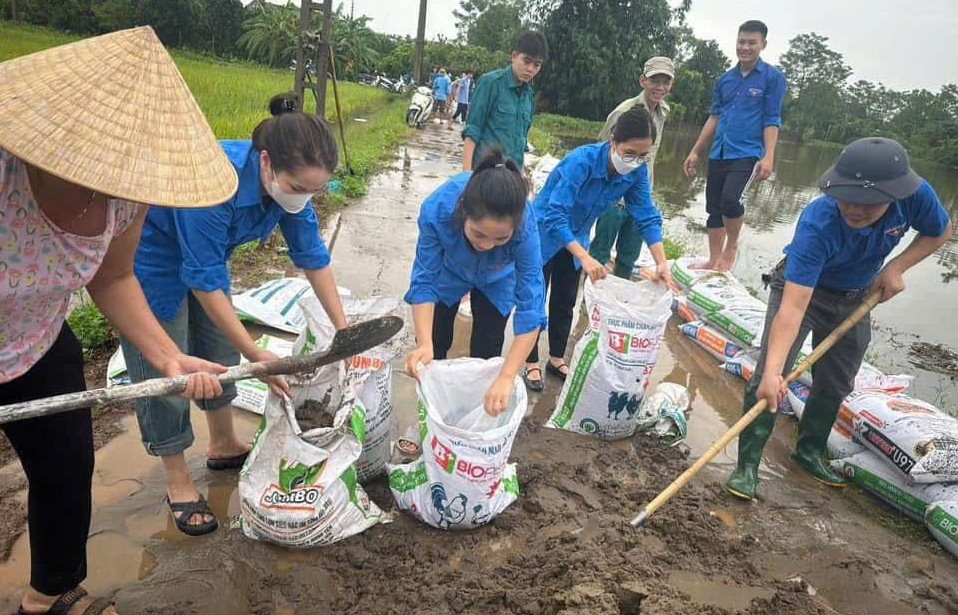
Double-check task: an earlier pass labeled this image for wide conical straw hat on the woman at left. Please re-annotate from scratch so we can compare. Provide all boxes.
[0,27,238,207]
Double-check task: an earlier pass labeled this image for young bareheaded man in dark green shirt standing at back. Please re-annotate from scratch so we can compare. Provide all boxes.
[462,32,549,171]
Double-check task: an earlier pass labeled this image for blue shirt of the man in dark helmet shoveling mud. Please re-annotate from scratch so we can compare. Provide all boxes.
[785,180,948,291]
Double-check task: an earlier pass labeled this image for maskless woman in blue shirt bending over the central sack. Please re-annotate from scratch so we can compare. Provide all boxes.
[405,150,545,416]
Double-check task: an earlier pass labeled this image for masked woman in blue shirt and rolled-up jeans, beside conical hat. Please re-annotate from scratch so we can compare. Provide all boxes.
[122,94,346,536]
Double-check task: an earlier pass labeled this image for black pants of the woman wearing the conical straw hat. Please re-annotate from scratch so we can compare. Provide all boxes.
[0,323,93,596]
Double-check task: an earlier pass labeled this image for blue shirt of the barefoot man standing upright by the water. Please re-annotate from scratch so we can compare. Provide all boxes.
[709,59,788,160]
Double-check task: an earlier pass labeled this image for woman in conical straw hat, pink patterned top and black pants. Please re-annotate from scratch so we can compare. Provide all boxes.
[0,28,237,615]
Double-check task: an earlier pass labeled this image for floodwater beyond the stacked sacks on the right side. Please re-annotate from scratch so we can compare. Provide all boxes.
[569,125,958,413]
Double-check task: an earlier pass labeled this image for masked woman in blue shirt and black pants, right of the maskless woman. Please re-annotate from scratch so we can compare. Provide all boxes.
[525,107,672,391]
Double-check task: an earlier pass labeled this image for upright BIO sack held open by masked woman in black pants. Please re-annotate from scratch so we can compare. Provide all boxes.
[546,276,672,439]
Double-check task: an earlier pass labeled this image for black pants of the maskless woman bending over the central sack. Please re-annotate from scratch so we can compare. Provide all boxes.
[432,289,509,359]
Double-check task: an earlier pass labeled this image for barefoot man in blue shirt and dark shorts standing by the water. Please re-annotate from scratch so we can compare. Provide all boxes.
[683,20,787,271]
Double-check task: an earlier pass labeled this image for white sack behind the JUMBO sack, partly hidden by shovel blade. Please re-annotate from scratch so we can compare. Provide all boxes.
[293,295,408,482]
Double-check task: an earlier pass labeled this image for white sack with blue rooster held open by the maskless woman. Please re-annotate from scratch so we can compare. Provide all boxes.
[387,358,528,530]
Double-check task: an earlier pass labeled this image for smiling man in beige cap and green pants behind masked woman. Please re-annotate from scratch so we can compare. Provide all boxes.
[589,56,675,279]
